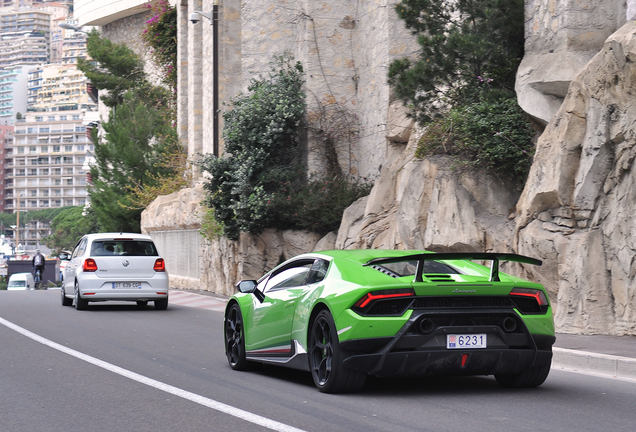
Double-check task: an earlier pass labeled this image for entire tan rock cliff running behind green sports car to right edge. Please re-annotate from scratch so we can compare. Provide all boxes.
[142,0,636,335]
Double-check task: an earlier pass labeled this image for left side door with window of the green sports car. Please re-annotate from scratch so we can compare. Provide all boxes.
[246,259,314,355]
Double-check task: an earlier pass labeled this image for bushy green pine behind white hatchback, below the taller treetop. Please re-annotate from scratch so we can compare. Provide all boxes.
[89,92,180,232]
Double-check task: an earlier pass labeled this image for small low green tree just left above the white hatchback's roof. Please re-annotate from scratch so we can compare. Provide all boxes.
[42,206,100,253]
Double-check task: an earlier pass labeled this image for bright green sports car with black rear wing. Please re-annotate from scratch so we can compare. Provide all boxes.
[224,250,555,393]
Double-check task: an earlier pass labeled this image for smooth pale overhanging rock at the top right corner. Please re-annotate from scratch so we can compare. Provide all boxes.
[515,0,636,125]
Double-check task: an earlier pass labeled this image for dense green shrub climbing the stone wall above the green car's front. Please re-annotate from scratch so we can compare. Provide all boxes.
[200,54,370,240]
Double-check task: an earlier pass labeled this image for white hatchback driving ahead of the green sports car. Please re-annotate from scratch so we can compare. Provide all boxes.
[62,233,169,310]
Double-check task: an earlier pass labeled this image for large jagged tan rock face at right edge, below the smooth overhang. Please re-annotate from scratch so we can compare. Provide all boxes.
[517,22,636,334]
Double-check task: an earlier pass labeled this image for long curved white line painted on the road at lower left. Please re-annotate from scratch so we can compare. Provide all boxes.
[0,317,304,432]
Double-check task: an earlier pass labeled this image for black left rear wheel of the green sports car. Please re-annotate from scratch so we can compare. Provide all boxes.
[307,310,367,393]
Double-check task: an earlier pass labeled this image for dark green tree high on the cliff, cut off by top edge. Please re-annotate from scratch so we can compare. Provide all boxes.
[389,0,524,124]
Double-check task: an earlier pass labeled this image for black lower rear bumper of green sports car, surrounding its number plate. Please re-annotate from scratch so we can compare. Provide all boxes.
[340,311,556,376]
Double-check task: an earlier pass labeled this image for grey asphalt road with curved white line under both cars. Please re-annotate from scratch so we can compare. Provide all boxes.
[0,291,636,432]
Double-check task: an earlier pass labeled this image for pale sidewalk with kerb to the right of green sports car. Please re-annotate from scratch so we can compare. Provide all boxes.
[552,333,636,381]
